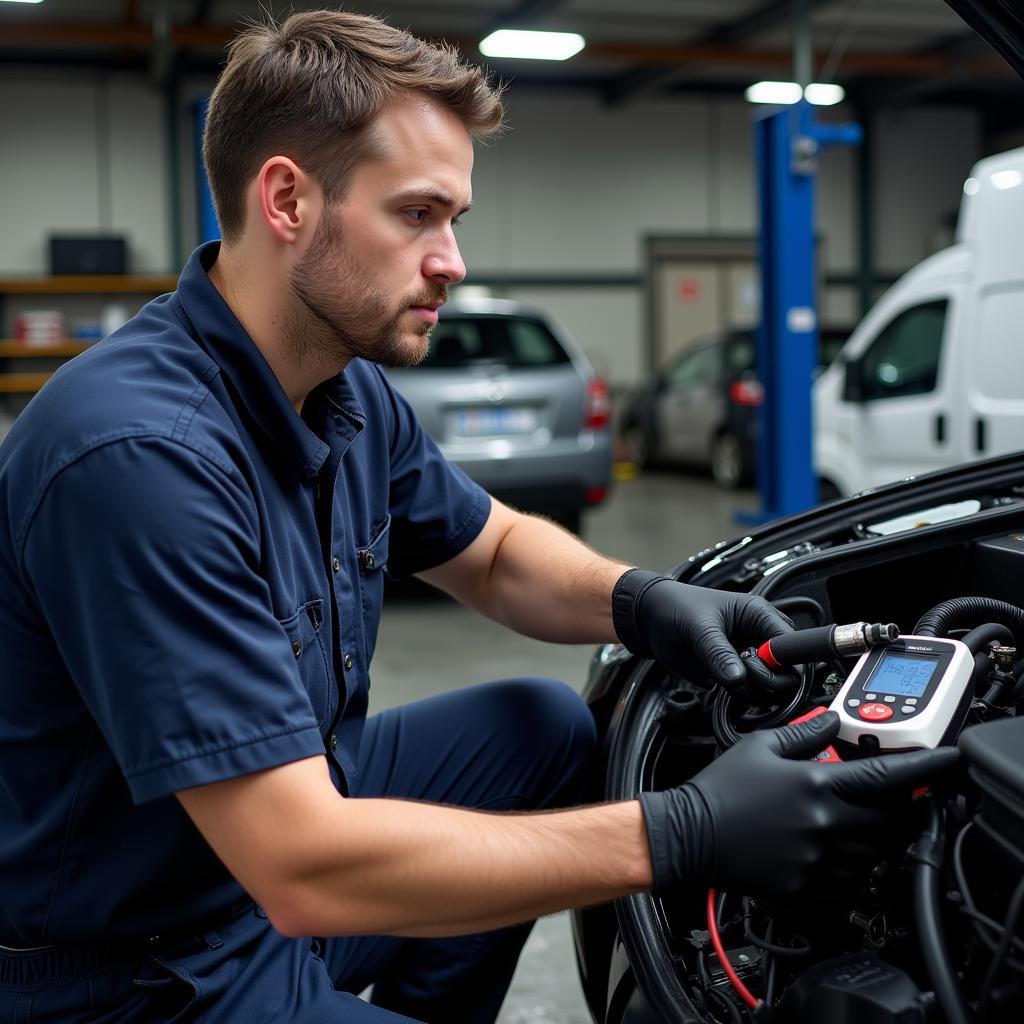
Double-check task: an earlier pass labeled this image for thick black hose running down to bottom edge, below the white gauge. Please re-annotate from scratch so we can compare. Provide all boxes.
[910,796,971,1024]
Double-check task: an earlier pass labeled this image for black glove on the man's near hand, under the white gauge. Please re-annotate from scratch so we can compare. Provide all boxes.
[640,712,959,904]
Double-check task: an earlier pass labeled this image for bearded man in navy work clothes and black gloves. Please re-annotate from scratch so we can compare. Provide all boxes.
[0,11,955,1024]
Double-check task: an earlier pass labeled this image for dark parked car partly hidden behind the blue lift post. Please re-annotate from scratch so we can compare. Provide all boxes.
[620,327,849,487]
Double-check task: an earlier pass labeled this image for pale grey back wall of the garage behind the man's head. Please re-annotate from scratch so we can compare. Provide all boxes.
[0,69,981,385]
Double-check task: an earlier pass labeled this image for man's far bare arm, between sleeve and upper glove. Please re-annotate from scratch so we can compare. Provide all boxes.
[424,503,630,643]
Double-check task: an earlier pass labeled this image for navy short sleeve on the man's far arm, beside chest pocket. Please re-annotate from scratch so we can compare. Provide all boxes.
[372,368,490,578]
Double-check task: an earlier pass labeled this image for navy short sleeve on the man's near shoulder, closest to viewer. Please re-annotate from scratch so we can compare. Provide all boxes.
[24,437,324,803]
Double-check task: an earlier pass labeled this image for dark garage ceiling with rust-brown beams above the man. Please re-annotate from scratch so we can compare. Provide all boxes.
[0,0,1024,127]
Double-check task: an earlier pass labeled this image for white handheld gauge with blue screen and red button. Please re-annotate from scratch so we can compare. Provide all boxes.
[831,636,974,752]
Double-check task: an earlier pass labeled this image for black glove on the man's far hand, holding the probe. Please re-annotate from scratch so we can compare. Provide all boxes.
[611,569,799,692]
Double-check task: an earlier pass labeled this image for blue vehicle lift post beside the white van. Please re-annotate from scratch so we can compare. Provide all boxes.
[753,97,861,522]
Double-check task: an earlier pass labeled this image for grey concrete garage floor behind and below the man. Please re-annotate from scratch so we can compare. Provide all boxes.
[371,472,757,1024]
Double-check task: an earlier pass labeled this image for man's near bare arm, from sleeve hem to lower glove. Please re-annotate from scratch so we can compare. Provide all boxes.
[178,758,652,936]
